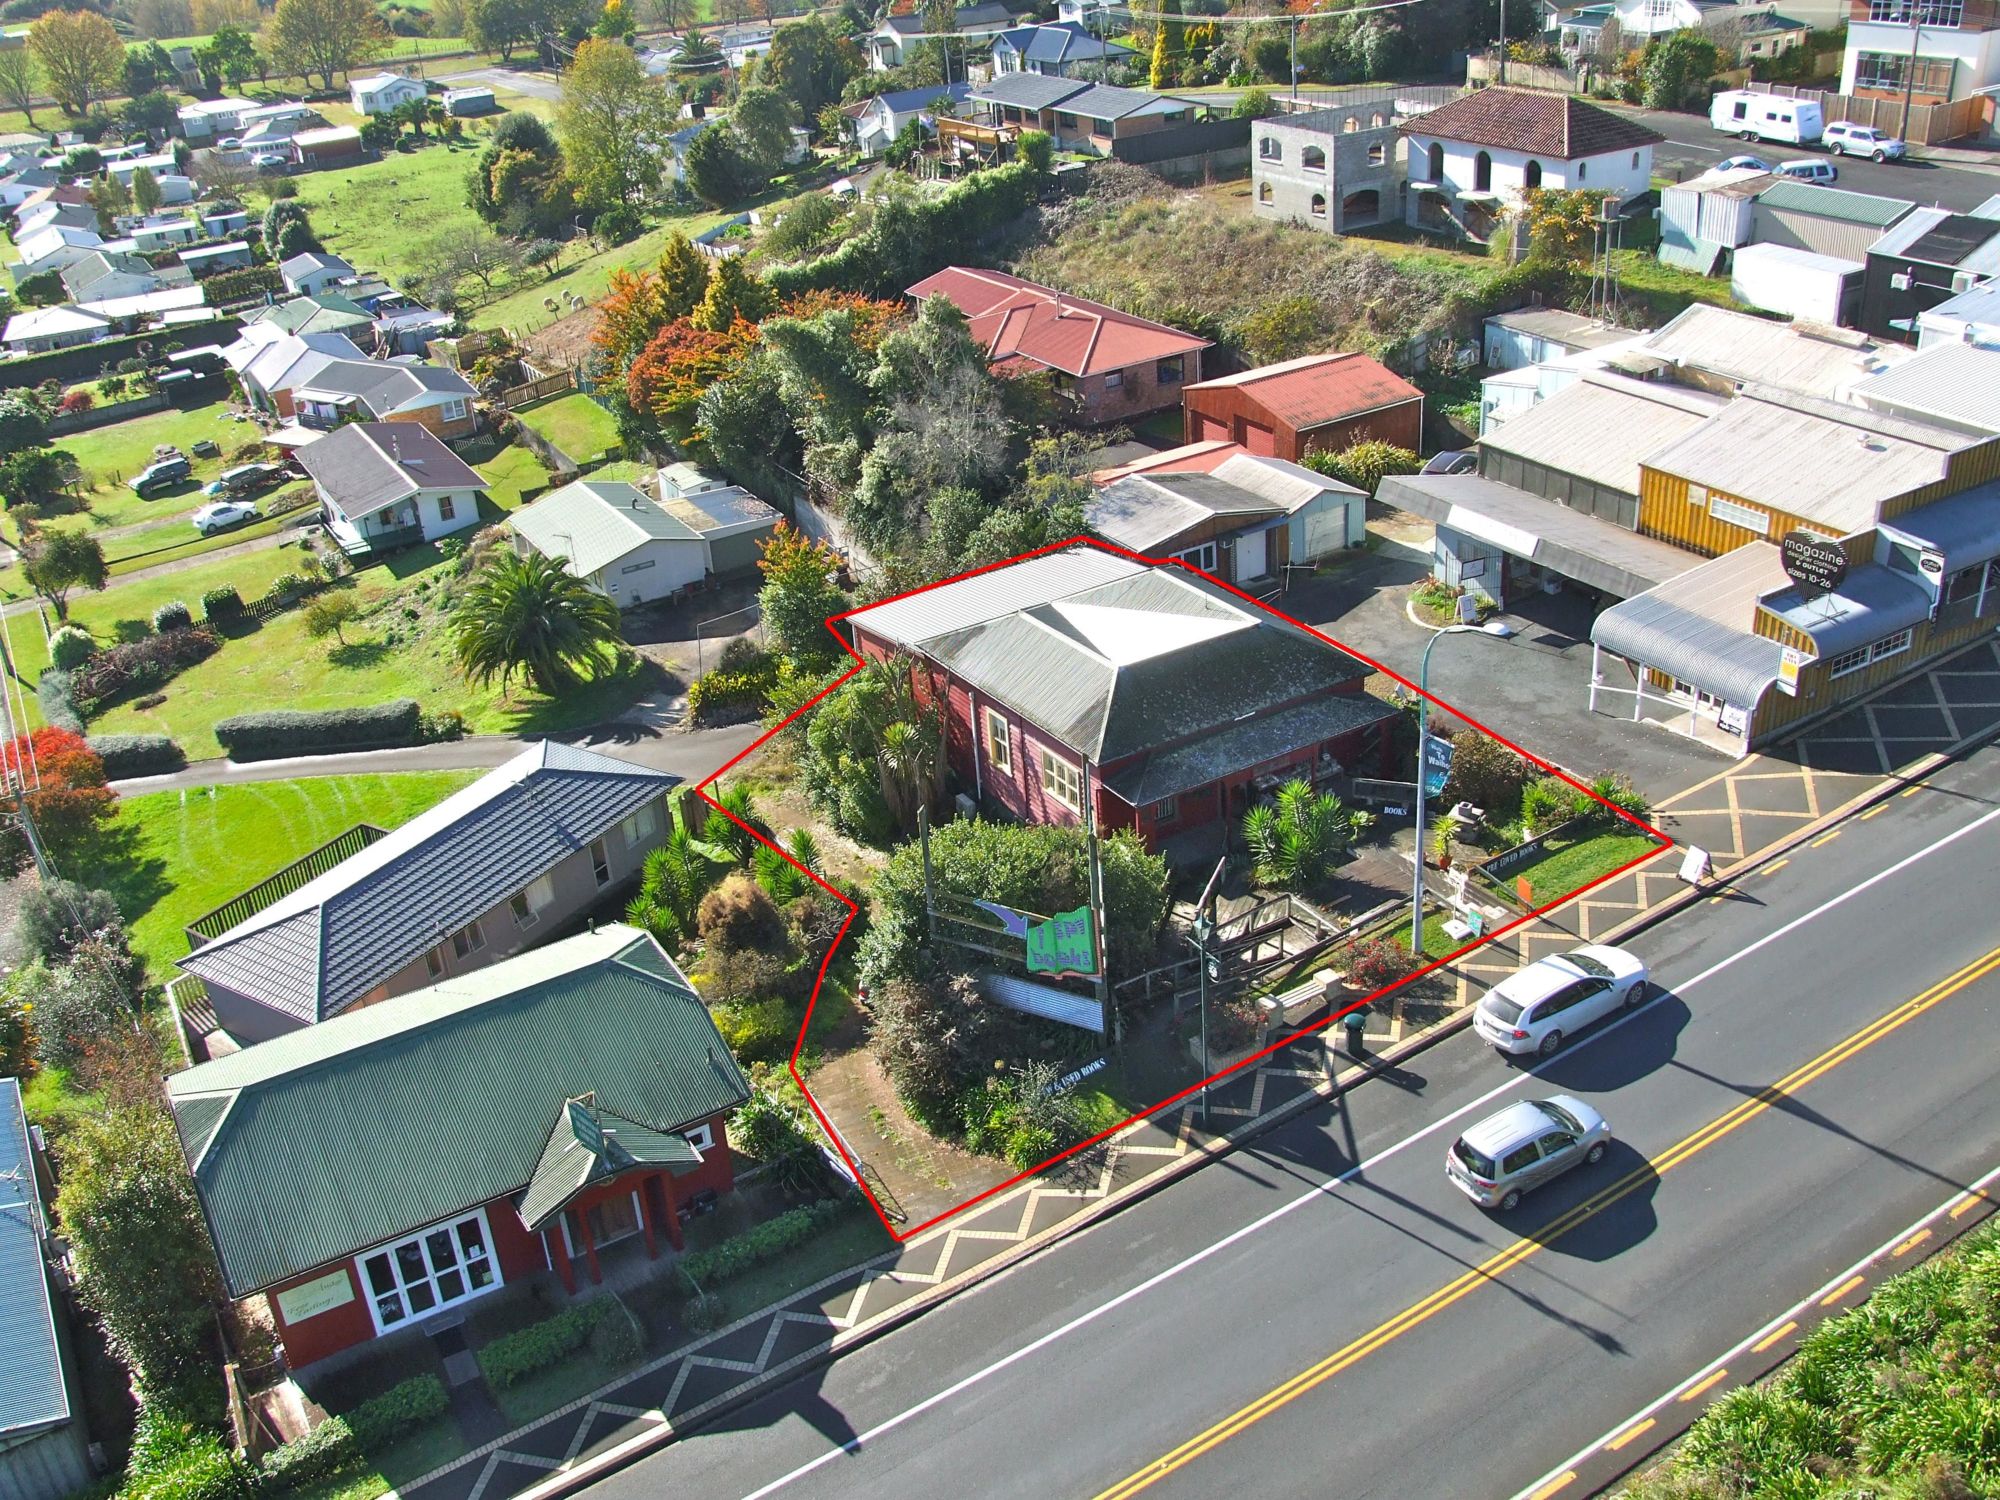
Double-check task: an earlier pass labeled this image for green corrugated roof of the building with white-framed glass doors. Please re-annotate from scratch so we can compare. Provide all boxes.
[168,926,750,1296]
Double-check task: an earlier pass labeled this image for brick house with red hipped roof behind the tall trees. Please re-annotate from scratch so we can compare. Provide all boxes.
[910,266,1210,426]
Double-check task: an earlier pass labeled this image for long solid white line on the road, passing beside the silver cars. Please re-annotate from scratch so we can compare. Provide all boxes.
[728,808,2000,1500]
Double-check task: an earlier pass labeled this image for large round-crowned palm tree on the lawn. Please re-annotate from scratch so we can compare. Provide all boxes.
[452,552,618,698]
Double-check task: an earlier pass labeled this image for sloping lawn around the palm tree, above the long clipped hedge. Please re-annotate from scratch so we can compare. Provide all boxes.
[90,548,650,760]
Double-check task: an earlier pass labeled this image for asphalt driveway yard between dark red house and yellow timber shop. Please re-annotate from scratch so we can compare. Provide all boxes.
[1276,518,1730,802]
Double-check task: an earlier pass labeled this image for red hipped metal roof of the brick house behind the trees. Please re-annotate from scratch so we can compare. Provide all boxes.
[910,266,1208,376]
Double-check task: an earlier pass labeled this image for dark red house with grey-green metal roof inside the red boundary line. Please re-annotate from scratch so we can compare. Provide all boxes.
[850,546,1398,848]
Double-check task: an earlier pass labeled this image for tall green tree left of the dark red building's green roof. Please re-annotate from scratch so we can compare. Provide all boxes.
[56,1094,220,1420]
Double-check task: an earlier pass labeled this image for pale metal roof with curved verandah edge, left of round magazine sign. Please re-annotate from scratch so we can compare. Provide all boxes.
[1590,542,1784,708]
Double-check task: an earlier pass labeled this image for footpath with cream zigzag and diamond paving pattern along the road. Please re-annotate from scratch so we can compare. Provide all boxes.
[386,640,2000,1500]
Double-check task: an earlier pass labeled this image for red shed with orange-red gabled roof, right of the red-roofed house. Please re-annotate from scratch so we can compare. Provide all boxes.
[1182,354,1424,464]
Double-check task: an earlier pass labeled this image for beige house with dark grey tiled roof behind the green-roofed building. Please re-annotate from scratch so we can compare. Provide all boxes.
[180,740,678,1042]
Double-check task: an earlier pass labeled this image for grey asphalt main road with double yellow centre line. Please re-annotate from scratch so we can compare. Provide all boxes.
[596,752,2000,1500]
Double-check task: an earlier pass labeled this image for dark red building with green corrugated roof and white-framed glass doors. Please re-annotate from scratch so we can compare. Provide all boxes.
[166,924,750,1368]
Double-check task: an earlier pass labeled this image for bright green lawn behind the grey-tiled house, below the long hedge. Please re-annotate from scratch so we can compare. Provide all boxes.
[76,770,478,980]
